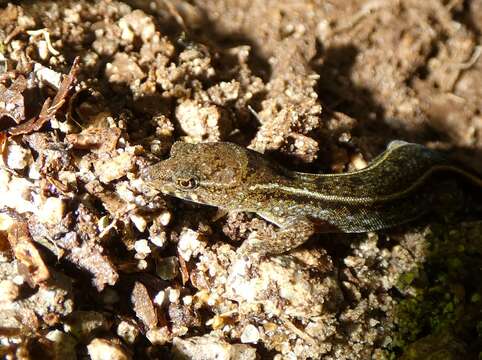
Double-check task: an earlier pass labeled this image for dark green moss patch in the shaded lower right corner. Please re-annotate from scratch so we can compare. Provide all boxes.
[389,222,482,359]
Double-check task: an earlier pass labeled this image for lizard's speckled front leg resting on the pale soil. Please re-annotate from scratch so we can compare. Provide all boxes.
[238,218,315,255]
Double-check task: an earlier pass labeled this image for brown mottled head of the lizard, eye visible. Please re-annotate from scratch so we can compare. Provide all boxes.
[141,142,248,208]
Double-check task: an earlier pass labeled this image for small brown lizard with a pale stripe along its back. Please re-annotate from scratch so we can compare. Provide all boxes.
[142,141,482,254]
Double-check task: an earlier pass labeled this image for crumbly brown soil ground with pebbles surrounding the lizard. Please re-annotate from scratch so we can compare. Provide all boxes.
[0,0,482,360]
